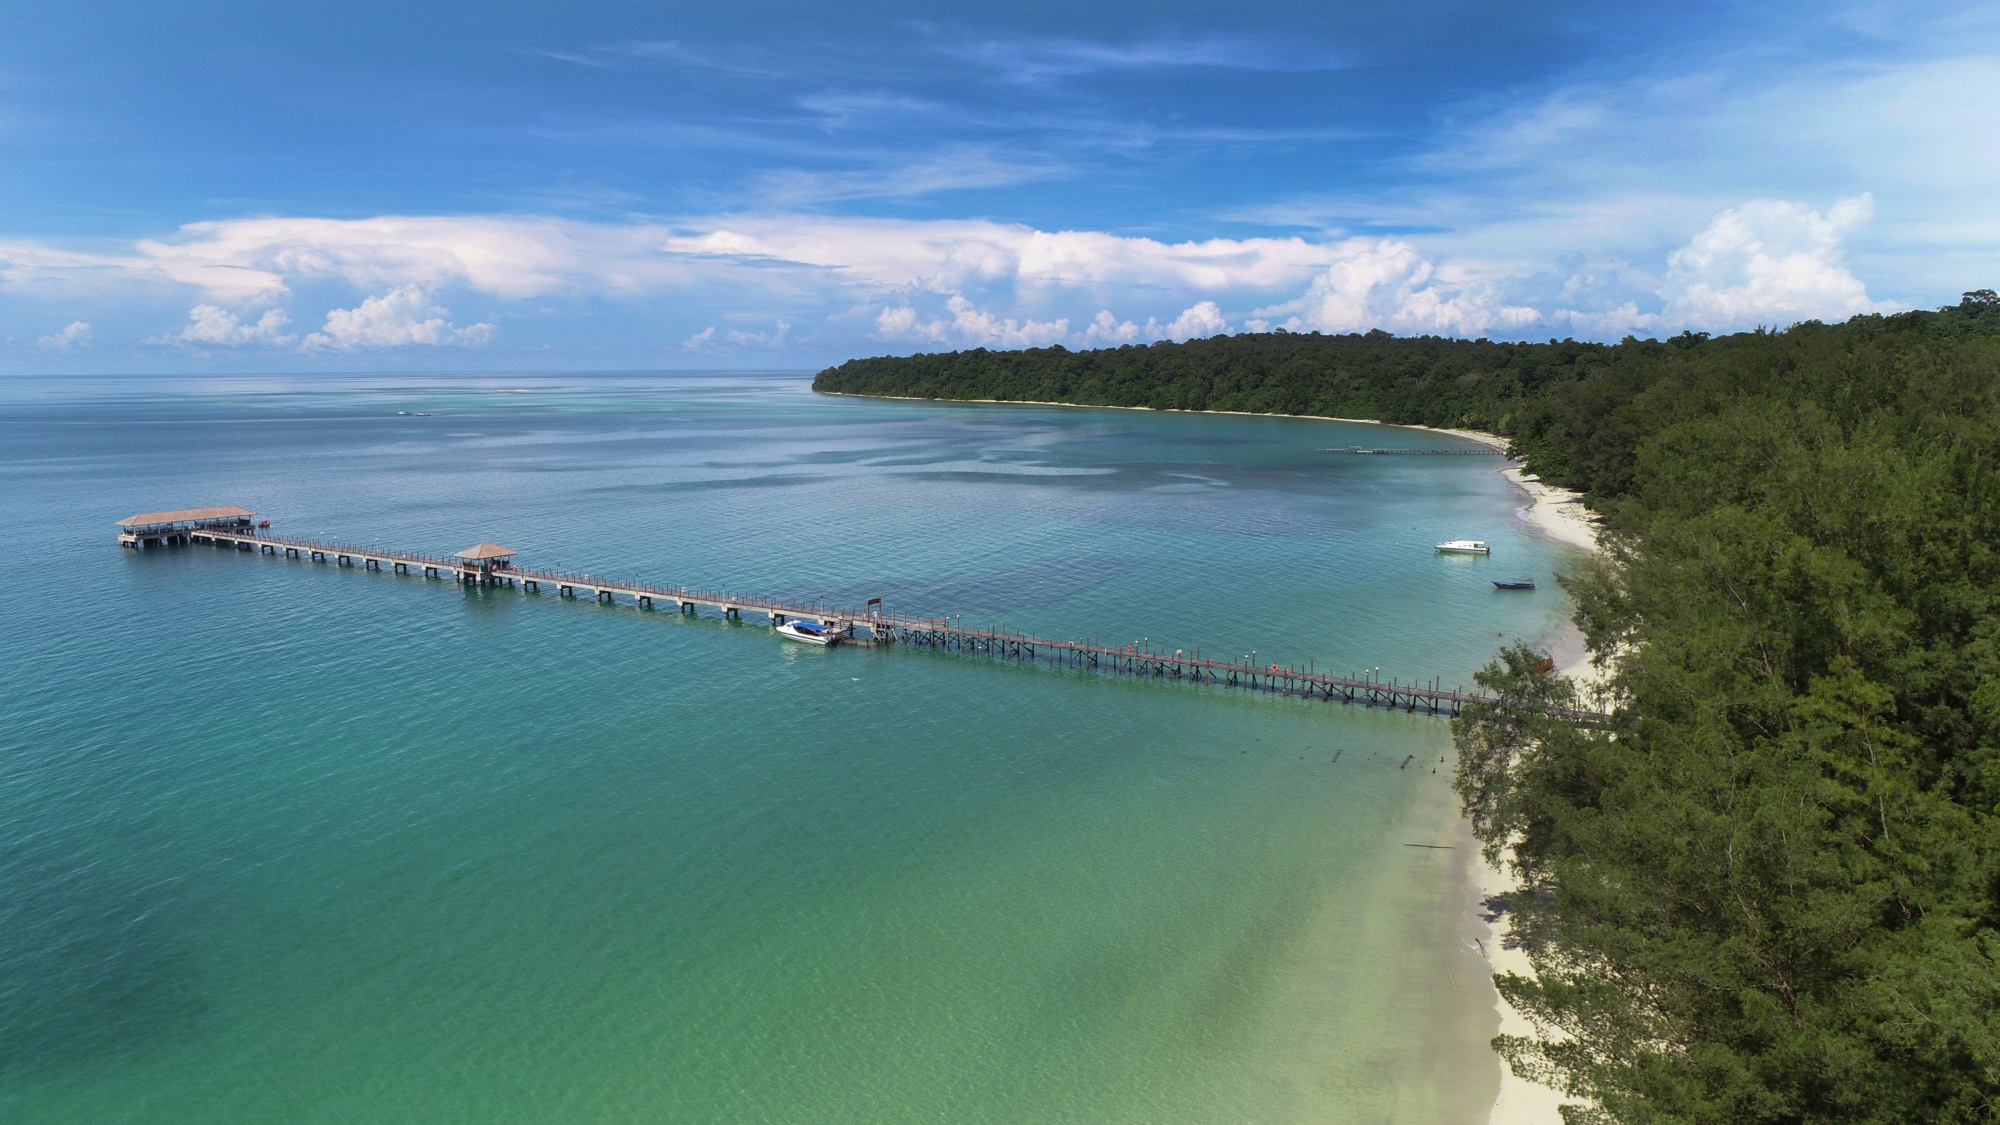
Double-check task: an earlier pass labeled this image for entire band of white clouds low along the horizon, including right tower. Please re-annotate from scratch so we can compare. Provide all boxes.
[0,188,1920,354]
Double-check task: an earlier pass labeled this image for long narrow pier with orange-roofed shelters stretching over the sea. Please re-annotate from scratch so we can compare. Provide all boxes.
[118,506,1602,723]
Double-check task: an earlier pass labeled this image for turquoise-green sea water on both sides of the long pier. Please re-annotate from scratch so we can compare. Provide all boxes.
[0,374,1564,1123]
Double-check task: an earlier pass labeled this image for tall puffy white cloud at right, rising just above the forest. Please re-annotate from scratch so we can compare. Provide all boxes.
[1660,192,1894,330]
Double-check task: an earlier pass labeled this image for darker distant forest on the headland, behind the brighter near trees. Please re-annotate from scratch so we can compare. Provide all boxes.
[812,290,2000,510]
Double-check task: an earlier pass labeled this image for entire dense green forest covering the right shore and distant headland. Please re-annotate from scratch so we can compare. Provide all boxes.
[816,290,2000,1125]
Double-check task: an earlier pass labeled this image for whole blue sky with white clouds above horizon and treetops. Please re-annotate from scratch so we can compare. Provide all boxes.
[0,0,2000,370]
